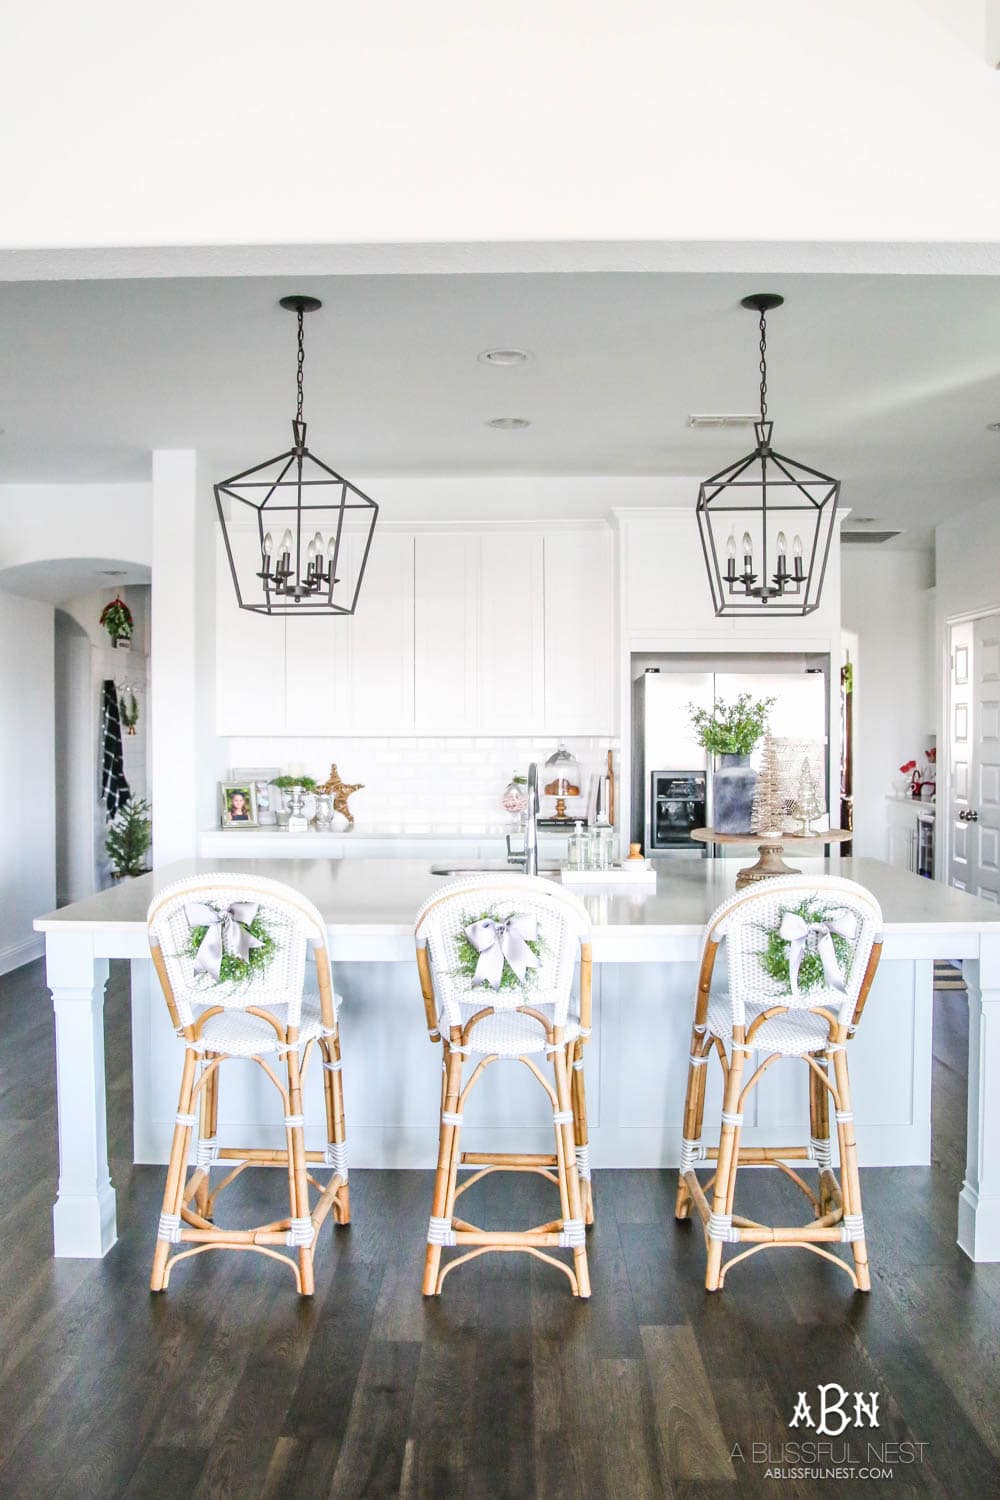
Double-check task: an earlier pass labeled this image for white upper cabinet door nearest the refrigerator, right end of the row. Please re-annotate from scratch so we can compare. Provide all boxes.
[544,530,615,735]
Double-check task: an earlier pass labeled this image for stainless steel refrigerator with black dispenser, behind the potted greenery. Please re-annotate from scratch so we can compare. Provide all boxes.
[631,659,829,855]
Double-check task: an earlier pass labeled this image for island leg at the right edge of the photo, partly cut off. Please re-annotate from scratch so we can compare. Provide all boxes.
[958,933,1000,1260]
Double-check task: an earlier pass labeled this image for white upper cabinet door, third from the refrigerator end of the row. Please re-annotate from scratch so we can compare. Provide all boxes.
[414,531,480,735]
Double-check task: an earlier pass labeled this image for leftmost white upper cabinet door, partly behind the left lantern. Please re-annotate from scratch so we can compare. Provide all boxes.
[216,527,285,735]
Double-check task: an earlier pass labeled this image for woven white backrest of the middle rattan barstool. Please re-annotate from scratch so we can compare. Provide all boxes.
[415,872,591,1026]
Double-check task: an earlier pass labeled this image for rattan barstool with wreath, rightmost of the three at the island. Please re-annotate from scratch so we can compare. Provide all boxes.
[676,875,882,1292]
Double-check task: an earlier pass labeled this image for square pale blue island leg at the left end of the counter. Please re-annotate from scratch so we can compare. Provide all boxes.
[45,932,118,1259]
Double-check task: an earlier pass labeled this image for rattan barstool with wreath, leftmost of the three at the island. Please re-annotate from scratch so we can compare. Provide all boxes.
[147,875,351,1296]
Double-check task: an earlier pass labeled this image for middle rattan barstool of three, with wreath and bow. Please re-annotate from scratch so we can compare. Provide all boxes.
[415,872,594,1298]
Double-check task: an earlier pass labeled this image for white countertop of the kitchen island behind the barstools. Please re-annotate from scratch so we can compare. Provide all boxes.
[34,858,1000,938]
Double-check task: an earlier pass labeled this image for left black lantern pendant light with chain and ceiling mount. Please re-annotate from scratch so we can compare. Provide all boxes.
[214,297,378,615]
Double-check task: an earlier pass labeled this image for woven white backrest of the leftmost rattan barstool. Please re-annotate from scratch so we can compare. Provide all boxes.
[147,873,328,1026]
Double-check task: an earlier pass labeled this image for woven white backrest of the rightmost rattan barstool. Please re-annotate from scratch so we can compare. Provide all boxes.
[705,875,882,1026]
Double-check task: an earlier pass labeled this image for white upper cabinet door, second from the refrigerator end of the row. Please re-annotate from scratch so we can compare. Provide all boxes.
[478,530,546,735]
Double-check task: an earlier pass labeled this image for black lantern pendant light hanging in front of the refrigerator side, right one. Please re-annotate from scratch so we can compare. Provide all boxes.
[697,293,840,615]
